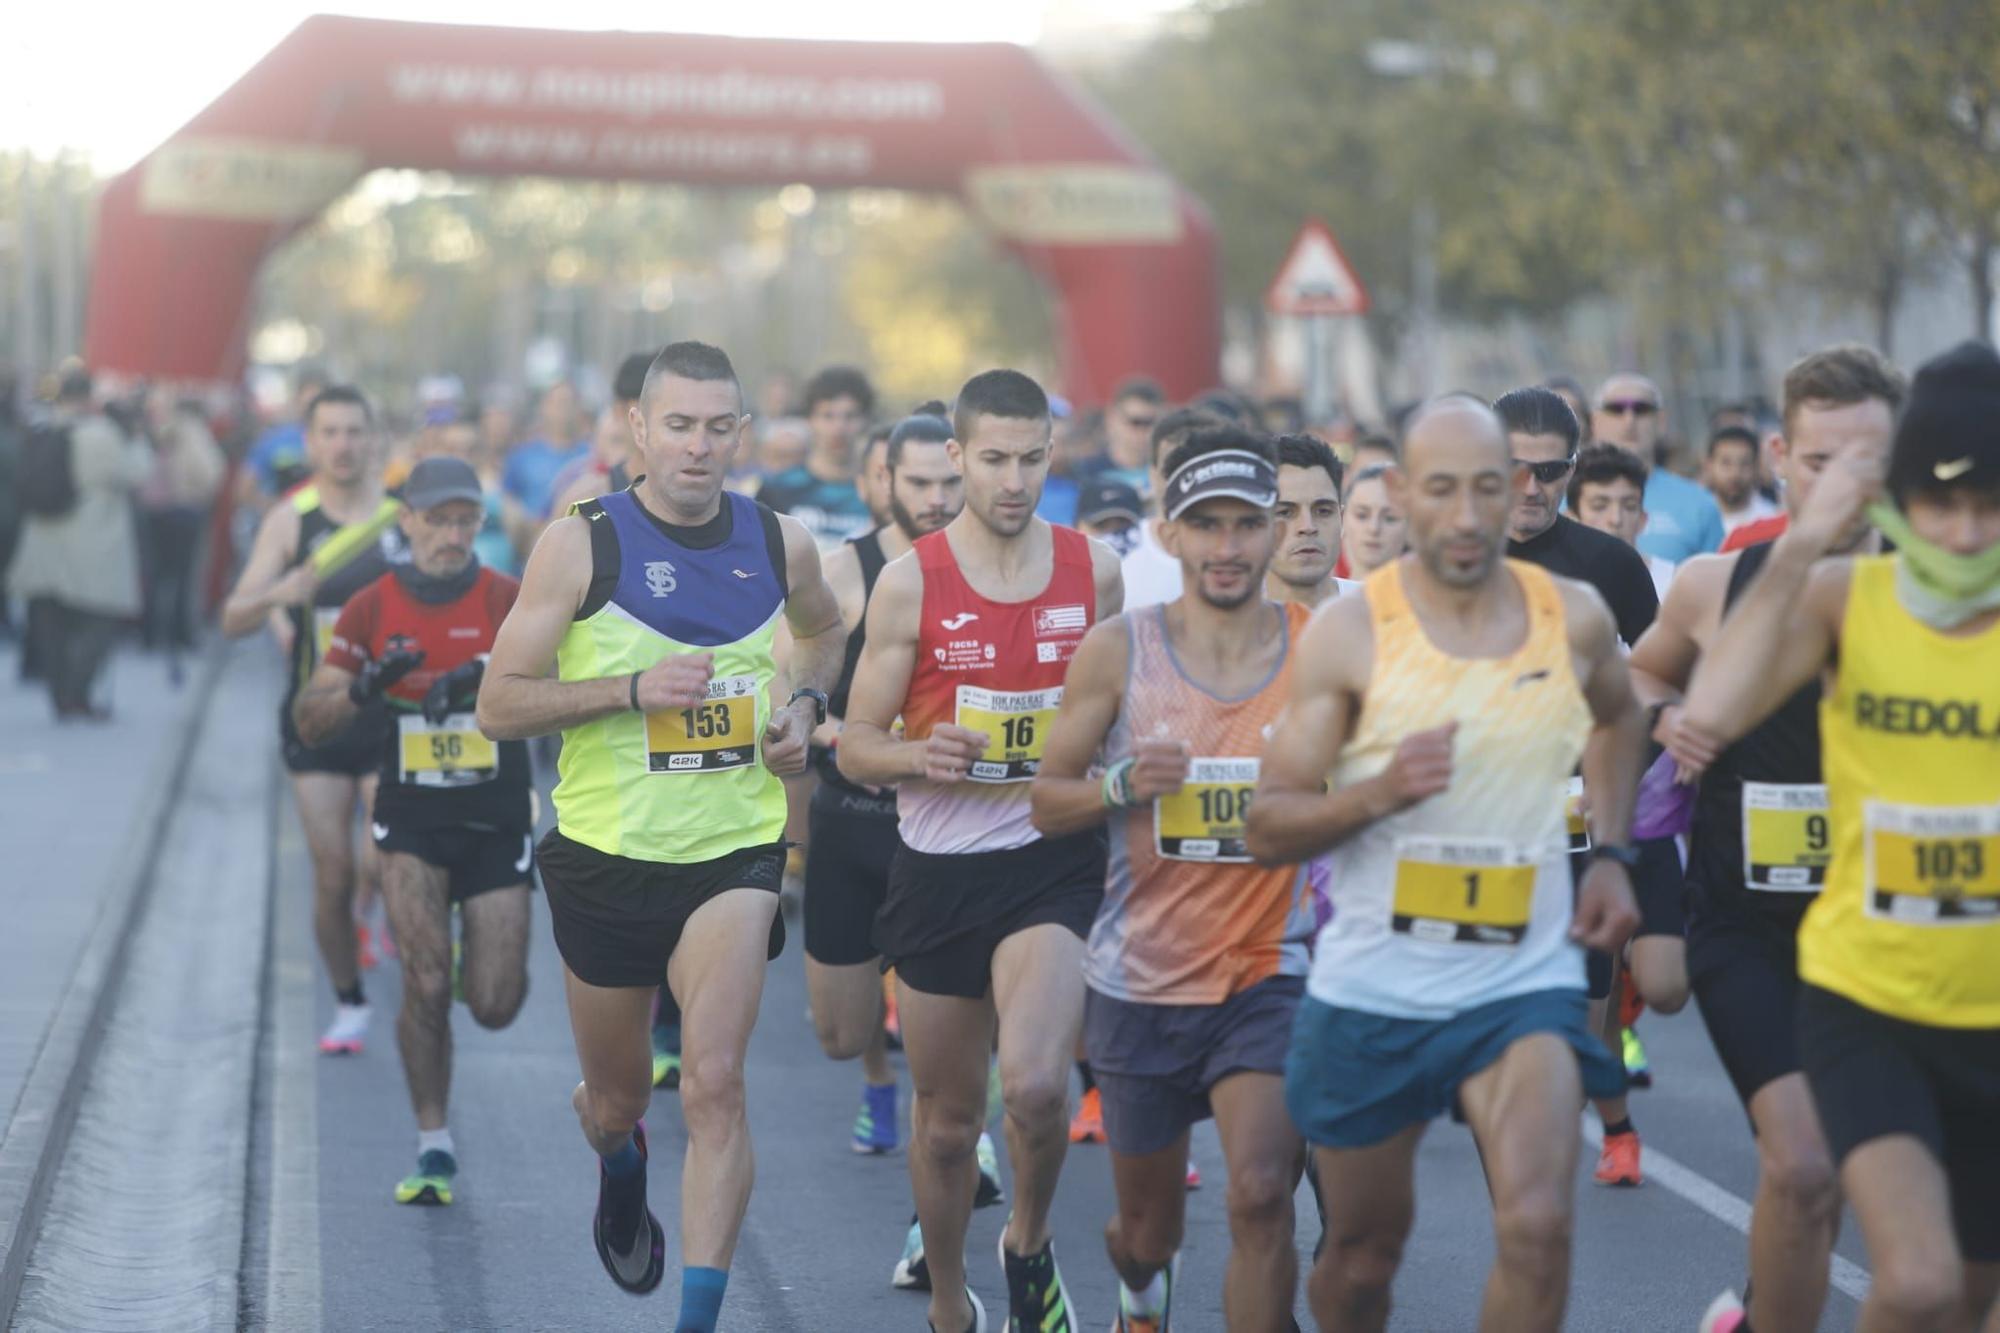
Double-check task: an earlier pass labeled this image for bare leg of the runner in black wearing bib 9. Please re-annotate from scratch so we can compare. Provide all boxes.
[1750,1073,1840,1333]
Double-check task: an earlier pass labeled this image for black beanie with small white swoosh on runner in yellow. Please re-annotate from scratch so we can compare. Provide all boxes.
[1888,340,2000,500]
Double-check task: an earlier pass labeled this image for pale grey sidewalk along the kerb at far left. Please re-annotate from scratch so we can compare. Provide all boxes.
[0,644,228,1313]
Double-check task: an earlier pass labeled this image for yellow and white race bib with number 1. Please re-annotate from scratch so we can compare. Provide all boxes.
[1390,839,1536,945]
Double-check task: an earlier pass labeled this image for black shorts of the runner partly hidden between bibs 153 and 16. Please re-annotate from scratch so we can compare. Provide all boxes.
[806,779,896,967]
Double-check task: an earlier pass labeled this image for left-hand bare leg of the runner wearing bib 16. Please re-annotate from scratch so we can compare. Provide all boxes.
[896,973,1000,1329]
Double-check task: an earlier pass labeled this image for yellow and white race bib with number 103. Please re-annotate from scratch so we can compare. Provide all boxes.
[1862,801,2000,927]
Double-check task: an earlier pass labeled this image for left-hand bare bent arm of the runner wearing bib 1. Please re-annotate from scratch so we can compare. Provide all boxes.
[1246,596,1404,865]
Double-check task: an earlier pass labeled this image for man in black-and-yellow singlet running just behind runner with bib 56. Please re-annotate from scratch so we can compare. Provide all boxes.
[222,384,408,1055]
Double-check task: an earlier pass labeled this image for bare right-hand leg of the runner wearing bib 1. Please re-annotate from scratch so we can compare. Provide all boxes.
[1458,1033,1584,1329]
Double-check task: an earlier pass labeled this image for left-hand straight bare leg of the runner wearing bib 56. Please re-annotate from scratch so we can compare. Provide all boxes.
[376,853,452,1131]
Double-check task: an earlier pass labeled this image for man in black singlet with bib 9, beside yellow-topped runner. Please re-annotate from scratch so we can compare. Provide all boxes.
[1632,346,1902,1333]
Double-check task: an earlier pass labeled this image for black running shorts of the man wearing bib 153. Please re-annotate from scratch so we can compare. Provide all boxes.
[538,829,784,987]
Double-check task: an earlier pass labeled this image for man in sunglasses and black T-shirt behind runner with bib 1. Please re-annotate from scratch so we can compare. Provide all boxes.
[1494,388,1688,1187]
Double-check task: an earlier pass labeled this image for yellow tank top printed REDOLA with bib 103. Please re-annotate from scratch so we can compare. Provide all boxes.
[1798,556,2000,1027]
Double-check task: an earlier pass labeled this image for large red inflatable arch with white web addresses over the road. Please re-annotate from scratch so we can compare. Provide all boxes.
[86,16,1220,402]
